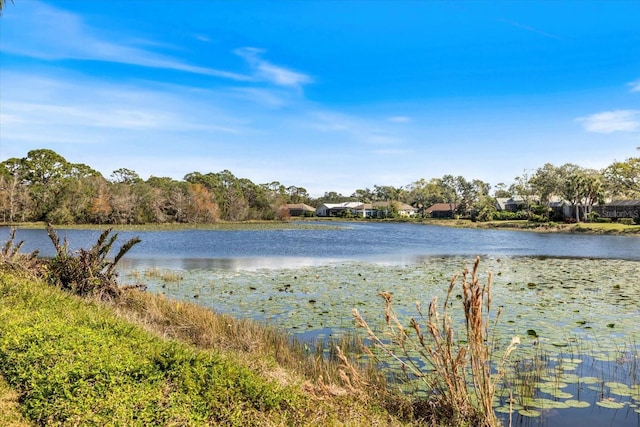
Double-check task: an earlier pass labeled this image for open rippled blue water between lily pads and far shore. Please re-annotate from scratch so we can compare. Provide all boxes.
[0,223,640,269]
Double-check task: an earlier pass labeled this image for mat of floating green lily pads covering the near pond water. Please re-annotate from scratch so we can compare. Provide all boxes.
[121,257,640,424]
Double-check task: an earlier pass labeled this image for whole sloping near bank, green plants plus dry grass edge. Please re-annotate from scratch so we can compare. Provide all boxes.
[0,273,410,425]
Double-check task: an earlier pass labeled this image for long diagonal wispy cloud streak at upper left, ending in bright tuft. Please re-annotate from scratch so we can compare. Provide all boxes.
[0,1,313,89]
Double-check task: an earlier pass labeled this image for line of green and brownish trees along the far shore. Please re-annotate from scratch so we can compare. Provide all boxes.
[0,149,640,224]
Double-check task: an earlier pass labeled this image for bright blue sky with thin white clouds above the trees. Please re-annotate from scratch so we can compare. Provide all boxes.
[0,0,640,196]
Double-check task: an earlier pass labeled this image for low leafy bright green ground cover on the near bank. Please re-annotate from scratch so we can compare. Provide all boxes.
[0,274,297,426]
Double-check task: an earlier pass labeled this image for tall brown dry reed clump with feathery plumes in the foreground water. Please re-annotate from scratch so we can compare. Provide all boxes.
[353,257,520,426]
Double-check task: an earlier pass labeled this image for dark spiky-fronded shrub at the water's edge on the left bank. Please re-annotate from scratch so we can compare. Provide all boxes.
[47,225,140,298]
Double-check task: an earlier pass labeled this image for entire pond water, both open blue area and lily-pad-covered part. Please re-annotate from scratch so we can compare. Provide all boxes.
[0,222,640,426]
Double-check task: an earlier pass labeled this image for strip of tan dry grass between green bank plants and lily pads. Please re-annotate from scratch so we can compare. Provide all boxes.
[113,290,386,395]
